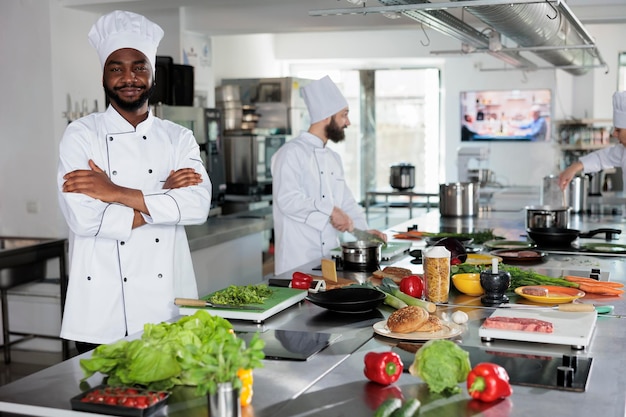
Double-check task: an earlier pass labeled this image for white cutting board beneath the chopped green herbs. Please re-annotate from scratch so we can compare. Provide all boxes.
[179,287,309,323]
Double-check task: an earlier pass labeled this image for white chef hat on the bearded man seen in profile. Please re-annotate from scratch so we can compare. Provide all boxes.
[302,75,348,123]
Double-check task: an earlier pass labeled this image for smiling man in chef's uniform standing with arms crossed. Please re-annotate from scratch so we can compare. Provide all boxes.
[57,11,211,352]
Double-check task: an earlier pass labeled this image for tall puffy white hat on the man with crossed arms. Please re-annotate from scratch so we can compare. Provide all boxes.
[88,10,164,71]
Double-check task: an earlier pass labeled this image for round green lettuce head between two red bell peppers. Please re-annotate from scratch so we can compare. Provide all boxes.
[409,340,472,394]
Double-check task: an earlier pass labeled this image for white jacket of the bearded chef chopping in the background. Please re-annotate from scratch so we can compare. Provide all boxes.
[272,132,367,275]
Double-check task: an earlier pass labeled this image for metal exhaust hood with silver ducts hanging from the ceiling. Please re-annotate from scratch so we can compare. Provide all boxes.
[309,0,608,75]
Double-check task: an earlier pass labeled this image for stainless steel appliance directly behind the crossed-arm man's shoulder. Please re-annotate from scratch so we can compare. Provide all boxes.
[154,104,226,211]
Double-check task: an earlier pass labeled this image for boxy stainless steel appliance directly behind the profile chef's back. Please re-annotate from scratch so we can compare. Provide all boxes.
[224,134,285,195]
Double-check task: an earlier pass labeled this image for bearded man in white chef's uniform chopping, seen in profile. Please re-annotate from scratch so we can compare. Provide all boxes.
[272,76,387,275]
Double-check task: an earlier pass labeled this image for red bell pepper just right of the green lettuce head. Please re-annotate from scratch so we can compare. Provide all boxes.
[467,362,513,403]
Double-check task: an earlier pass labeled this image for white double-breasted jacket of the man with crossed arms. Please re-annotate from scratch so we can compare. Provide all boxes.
[57,106,211,344]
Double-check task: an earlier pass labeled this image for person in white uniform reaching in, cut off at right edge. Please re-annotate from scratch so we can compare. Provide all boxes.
[559,91,626,190]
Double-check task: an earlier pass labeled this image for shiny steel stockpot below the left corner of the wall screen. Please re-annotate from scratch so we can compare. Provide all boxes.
[439,182,480,217]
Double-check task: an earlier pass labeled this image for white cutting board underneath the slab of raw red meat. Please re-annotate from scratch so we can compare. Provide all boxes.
[478,308,598,347]
